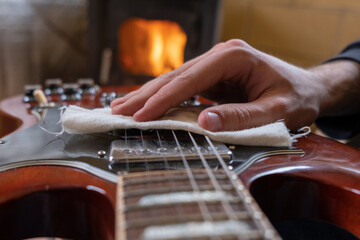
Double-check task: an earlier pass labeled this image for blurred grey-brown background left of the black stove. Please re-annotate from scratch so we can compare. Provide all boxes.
[0,0,87,99]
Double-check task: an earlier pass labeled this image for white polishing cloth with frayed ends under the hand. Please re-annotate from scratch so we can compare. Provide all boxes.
[62,106,294,147]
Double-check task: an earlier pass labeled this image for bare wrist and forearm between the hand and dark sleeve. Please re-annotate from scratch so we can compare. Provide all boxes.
[309,60,360,117]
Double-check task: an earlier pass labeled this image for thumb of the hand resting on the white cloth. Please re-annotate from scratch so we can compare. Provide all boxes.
[198,102,280,132]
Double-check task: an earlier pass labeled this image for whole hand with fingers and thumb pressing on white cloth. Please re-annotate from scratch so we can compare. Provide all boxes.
[111,40,322,131]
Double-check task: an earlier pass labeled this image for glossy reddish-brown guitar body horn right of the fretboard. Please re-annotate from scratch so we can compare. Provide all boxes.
[240,134,360,237]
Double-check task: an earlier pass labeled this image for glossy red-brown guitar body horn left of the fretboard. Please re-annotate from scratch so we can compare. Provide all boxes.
[0,166,116,240]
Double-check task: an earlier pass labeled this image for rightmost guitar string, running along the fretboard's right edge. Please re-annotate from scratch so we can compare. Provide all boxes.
[205,136,267,238]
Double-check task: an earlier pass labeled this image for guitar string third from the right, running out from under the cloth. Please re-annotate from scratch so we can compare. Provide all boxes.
[171,130,213,221]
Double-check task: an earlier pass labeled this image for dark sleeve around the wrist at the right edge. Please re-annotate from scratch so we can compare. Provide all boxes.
[316,39,360,139]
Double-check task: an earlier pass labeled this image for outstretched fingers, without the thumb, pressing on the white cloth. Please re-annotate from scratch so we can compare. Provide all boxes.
[111,41,262,125]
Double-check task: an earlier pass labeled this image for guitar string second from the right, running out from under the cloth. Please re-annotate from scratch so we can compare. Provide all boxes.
[188,132,238,221]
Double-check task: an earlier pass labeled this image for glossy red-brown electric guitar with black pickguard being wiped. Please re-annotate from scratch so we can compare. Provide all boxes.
[0,87,360,239]
